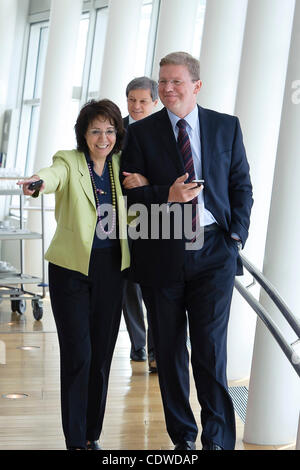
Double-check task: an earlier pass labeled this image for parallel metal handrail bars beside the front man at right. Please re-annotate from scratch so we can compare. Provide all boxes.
[235,253,300,377]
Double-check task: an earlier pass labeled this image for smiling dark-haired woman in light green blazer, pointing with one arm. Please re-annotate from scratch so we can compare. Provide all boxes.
[19,100,130,449]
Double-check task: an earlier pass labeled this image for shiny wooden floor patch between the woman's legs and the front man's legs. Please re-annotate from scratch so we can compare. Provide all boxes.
[101,322,173,450]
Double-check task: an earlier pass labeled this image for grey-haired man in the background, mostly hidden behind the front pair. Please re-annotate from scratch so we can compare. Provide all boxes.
[123,77,158,372]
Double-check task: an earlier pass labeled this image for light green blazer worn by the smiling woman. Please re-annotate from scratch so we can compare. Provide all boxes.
[38,150,130,275]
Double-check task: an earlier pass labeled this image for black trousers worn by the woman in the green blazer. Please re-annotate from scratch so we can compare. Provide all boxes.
[49,248,123,448]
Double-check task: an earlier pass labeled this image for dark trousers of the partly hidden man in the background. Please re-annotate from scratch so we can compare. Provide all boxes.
[123,280,153,354]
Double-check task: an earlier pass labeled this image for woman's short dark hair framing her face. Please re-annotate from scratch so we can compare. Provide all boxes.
[75,99,125,153]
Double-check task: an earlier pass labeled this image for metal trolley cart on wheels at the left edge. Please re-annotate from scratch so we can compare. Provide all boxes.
[0,185,47,320]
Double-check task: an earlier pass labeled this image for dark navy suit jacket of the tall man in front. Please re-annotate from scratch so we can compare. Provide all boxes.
[121,106,253,285]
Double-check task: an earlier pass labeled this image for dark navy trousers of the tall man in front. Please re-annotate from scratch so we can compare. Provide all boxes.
[142,230,238,449]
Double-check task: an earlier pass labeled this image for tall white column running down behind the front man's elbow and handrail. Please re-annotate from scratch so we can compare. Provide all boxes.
[226,0,295,380]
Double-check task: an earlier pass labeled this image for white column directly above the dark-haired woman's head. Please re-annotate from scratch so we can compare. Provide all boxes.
[100,0,143,116]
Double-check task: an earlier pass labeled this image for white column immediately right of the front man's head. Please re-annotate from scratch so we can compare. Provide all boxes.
[198,0,248,114]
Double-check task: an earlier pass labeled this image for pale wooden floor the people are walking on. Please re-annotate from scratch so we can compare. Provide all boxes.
[0,298,294,450]
